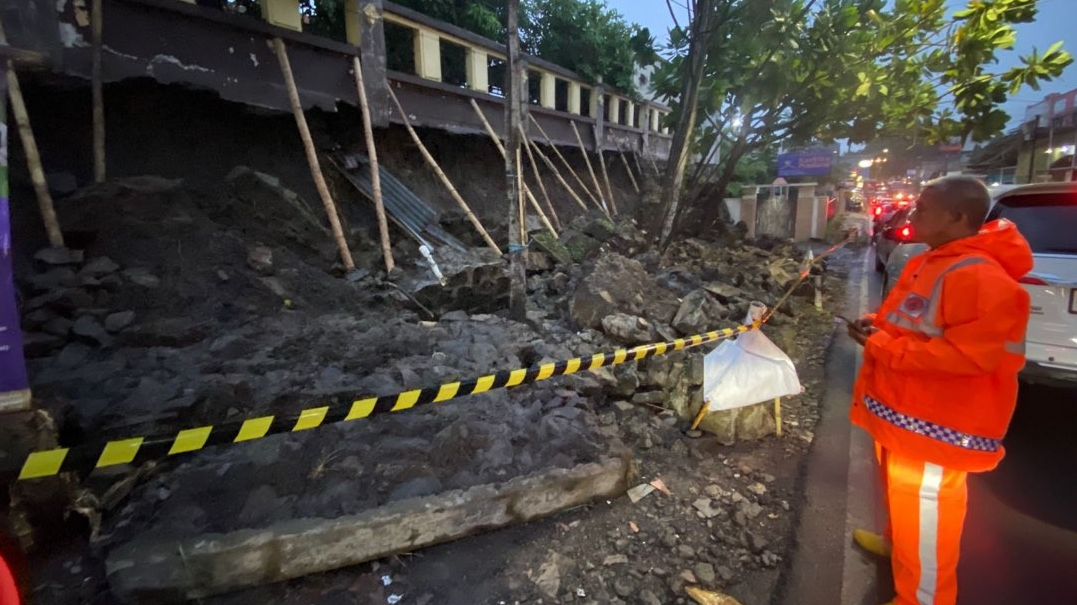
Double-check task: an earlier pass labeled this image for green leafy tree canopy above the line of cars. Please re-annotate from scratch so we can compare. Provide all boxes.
[653,0,1073,233]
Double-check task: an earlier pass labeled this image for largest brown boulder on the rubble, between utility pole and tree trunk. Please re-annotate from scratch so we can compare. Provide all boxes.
[569,254,677,329]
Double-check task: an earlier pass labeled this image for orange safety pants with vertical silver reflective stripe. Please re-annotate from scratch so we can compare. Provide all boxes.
[876,444,968,605]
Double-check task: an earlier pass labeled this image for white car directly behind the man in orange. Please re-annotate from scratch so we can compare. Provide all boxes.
[883,182,1077,383]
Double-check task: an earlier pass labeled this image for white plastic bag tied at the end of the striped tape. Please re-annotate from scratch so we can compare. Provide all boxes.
[703,303,801,411]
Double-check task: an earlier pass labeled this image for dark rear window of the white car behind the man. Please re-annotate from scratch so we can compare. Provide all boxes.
[991,191,1077,254]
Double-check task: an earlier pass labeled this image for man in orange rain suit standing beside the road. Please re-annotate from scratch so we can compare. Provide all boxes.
[849,177,1032,605]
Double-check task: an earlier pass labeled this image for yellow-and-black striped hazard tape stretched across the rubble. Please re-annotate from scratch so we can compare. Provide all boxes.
[12,244,843,480]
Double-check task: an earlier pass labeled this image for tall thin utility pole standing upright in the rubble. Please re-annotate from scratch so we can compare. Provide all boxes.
[505,0,528,322]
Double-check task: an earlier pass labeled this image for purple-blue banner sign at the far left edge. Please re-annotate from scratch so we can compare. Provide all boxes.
[0,65,30,411]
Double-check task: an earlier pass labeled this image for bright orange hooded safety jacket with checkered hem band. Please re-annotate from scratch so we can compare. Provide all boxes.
[851,220,1033,472]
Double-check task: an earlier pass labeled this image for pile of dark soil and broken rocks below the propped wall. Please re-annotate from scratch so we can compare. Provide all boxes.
[17,170,833,603]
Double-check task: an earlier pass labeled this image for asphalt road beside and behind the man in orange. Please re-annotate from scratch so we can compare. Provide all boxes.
[773,246,1077,605]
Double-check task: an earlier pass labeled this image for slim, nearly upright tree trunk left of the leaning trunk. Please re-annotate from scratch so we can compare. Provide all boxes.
[658,0,715,244]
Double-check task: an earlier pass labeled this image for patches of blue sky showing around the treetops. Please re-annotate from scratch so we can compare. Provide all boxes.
[605,0,1077,128]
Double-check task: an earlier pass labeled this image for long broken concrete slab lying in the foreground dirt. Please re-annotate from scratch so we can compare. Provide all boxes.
[106,458,629,603]
